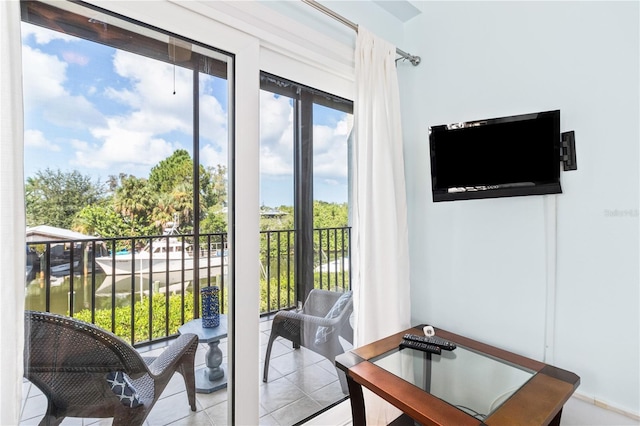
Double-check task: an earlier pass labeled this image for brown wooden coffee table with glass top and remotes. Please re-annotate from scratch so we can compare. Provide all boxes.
[336,325,580,426]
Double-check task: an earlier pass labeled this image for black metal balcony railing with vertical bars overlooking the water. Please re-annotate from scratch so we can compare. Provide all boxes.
[26,228,351,346]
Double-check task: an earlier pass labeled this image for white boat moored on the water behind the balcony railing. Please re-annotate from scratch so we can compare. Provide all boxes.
[95,237,228,275]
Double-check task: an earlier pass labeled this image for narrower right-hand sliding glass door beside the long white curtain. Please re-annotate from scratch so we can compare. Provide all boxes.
[260,73,353,424]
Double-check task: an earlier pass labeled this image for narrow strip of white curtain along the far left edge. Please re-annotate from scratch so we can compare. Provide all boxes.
[0,0,26,425]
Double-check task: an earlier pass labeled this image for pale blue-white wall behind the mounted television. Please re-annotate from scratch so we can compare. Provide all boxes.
[399,2,640,415]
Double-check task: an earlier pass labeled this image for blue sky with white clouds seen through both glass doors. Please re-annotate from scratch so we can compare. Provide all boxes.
[22,23,351,207]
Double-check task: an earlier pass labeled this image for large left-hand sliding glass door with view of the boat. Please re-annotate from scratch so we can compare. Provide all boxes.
[22,1,234,424]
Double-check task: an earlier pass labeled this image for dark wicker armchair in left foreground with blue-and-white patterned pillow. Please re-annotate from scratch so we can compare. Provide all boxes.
[24,311,198,425]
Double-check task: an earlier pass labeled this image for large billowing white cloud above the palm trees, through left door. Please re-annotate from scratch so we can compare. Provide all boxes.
[84,51,228,173]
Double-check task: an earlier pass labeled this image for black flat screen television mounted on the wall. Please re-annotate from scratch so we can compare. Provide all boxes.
[429,110,562,201]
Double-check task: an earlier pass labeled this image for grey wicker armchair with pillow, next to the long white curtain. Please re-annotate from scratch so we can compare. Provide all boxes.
[262,289,353,394]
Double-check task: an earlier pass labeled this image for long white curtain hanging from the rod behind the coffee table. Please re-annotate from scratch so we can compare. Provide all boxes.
[351,27,411,425]
